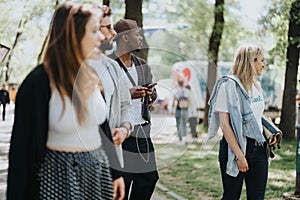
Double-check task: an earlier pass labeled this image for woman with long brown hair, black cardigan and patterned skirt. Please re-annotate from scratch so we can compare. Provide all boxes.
[7,3,123,200]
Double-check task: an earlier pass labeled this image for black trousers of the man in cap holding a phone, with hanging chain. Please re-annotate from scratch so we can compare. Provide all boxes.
[122,123,159,200]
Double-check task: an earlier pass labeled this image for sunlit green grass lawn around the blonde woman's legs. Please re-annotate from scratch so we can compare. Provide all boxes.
[155,130,296,200]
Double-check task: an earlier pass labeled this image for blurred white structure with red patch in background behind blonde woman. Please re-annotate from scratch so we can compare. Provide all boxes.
[156,60,283,122]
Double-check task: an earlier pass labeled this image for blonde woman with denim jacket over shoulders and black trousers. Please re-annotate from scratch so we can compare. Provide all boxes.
[208,45,268,200]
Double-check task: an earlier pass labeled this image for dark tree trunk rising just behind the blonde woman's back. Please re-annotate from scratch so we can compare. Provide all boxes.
[203,0,224,126]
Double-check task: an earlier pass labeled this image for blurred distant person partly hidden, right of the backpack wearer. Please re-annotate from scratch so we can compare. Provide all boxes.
[185,85,198,138]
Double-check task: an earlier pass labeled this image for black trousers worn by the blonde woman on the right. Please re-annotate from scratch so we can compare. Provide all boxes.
[219,137,268,200]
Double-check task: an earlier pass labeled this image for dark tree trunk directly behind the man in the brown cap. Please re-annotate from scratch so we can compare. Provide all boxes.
[125,0,148,60]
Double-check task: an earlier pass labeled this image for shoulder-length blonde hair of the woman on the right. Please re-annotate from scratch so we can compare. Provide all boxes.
[232,45,263,92]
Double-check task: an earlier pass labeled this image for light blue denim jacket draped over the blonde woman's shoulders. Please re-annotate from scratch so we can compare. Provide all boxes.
[208,75,265,177]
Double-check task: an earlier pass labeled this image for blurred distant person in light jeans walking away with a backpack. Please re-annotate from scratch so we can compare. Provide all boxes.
[171,80,190,145]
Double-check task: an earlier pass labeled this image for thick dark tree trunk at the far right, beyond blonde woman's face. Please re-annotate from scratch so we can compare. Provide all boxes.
[279,0,300,140]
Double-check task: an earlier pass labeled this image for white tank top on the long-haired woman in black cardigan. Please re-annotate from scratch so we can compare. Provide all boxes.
[47,88,106,150]
